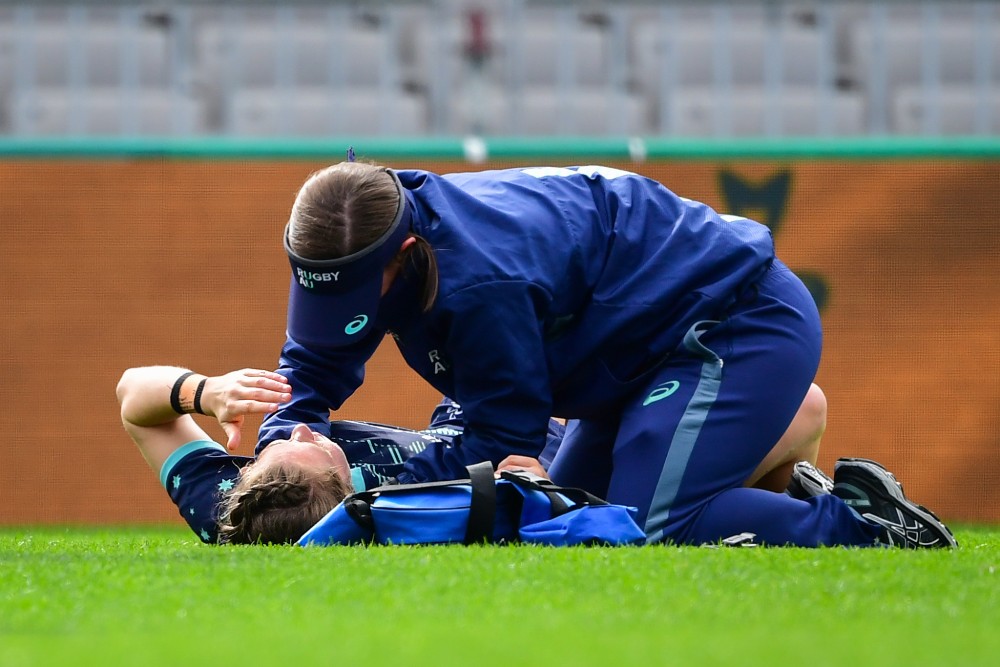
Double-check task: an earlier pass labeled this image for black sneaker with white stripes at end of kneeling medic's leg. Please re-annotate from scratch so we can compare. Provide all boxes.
[833,459,958,549]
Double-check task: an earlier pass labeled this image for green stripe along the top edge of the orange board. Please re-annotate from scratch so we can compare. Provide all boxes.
[0,137,1000,162]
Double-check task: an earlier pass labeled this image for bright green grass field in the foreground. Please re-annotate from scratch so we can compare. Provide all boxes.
[0,528,1000,667]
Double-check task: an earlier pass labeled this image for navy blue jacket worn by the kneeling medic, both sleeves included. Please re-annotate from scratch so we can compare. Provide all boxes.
[258,167,774,482]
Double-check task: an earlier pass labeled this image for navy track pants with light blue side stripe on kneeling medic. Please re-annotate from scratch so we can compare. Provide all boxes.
[549,261,877,546]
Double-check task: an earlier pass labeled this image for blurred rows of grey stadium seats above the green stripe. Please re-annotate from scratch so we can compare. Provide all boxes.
[0,0,1000,137]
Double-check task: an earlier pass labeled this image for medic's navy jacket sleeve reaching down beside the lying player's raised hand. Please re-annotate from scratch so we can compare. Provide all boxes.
[256,330,384,454]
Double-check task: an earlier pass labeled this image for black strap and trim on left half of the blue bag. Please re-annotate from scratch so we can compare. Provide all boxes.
[344,461,497,544]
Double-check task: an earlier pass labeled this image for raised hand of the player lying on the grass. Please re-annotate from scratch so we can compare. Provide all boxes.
[201,368,292,451]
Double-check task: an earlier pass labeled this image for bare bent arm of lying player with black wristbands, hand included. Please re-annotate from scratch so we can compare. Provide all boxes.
[117,366,291,471]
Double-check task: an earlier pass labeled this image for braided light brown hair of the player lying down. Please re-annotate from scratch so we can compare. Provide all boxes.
[219,463,351,544]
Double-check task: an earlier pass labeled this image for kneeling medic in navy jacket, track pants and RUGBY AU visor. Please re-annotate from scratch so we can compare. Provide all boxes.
[258,160,950,546]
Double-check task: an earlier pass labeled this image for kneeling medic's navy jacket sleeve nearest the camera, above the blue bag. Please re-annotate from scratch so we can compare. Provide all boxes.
[398,281,552,483]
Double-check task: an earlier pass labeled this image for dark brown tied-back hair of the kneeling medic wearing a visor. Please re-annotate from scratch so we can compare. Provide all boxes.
[288,162,438,311]
